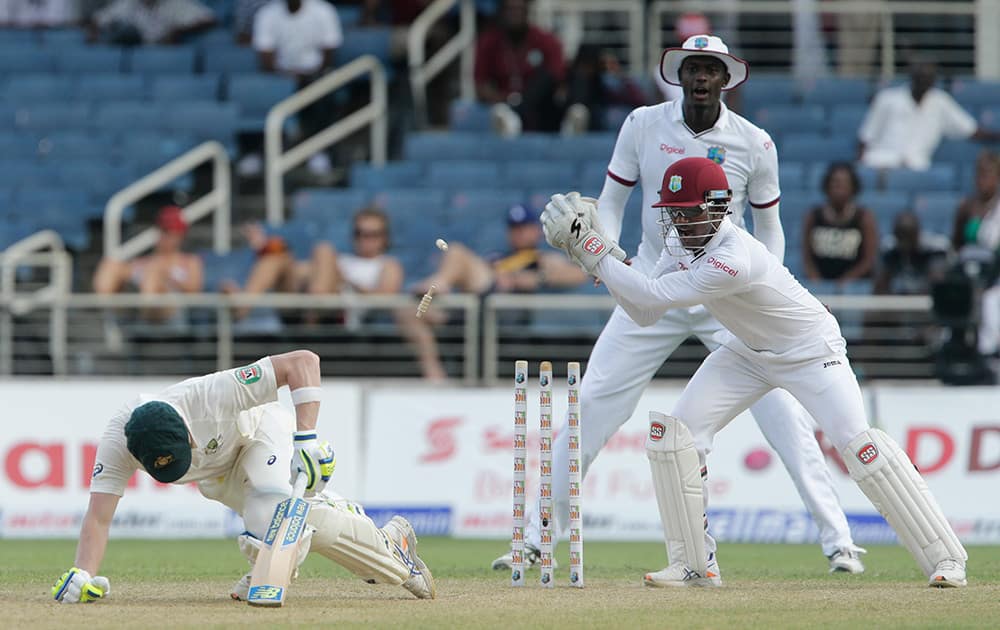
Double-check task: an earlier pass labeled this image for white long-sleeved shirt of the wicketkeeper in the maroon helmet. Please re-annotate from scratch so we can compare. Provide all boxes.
[598,219,846,360]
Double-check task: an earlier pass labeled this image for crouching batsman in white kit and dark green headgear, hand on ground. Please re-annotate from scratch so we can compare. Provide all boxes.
[52,350,435,605]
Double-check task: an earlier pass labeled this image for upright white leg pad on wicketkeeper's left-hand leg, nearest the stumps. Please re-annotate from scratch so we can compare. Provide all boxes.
[646,411,708,577]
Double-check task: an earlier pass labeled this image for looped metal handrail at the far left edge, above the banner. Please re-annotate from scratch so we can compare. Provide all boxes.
[0,230,73,376]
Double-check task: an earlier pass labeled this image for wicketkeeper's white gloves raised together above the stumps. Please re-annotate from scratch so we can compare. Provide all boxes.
[542,190,625,275]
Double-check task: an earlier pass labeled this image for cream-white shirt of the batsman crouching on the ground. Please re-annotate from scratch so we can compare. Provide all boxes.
[90,357,278,496]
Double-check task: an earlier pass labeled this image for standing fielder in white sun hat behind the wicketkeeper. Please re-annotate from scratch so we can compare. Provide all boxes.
[493,35,865,573]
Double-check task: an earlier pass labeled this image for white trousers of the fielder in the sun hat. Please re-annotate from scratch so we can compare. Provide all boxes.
[526,307,852,556]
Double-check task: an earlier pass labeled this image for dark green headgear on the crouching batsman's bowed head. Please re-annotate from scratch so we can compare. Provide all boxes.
[125,400,191,483]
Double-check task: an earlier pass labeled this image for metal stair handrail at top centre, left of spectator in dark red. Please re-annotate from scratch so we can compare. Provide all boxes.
[406,0,476,128]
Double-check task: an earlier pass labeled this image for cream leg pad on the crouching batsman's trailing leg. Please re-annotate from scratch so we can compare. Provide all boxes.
[309,502,410,584]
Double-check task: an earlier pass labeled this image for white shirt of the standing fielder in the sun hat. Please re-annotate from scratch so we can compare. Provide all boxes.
[600,100,781,273]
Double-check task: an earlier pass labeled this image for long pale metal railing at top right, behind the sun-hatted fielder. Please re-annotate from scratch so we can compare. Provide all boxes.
[646,0,980,78]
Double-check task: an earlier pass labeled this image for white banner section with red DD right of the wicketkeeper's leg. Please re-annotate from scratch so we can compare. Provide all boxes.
[875,387,1000,544]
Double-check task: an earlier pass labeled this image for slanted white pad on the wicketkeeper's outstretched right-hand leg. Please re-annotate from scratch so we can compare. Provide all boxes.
[841,429,969,577]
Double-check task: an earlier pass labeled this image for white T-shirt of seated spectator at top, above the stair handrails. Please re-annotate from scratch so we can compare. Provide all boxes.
[253,0,344,73]
